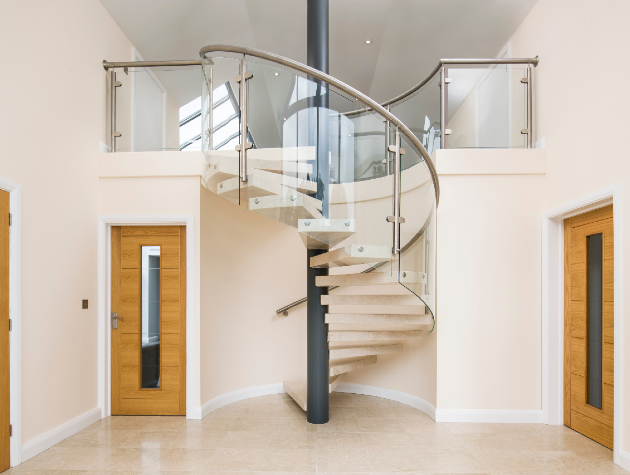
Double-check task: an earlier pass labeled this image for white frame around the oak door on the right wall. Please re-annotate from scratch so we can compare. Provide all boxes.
[541,184,624,465]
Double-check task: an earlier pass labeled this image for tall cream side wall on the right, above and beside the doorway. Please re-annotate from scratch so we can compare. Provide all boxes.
[511,0,630,451]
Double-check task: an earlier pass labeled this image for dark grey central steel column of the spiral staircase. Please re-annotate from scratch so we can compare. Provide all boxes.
[306,0,330,424]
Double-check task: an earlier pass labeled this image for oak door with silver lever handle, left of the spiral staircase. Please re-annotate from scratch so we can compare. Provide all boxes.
[111,226,186,415]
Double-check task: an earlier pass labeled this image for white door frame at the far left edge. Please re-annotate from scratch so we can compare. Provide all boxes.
[0,178,22,467]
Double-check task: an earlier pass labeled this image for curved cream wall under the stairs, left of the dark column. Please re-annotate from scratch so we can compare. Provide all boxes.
[201,188,306,403]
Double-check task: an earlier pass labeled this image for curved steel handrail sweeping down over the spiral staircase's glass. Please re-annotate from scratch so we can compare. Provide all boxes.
[199,45,440,206]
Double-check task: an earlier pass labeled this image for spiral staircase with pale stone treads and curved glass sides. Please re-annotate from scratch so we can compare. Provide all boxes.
[200,45,439,411]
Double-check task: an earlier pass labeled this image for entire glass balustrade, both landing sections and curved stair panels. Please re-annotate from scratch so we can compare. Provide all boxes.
[105,48,531,326]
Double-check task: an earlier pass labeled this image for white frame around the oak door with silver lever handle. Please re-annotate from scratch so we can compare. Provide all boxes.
[98,218,199,419]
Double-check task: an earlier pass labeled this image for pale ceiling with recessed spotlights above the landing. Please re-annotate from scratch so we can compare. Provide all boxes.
[101,0,536,106]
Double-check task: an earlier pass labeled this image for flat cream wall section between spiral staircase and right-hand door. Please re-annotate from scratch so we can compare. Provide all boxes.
[437,150,544,410]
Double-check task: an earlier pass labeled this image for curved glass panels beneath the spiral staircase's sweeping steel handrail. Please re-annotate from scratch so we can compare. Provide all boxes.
[202,54,440,318]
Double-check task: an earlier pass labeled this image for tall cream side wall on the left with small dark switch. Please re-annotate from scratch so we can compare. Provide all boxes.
[0,0,131,443]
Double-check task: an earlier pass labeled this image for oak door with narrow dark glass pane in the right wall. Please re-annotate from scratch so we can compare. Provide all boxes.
[564,205,614,449]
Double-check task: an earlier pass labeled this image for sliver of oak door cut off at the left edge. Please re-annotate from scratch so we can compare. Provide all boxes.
[0,190,11,472]
